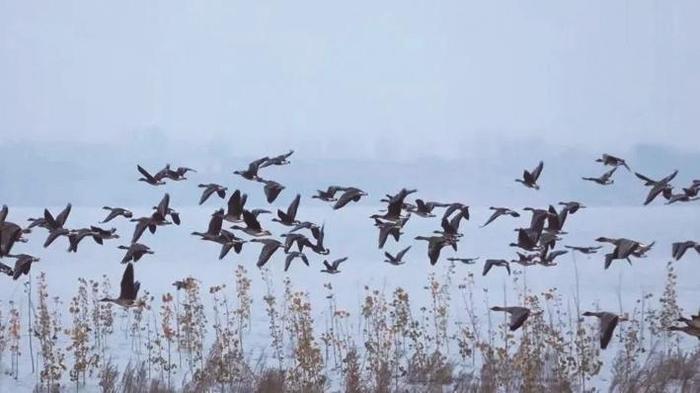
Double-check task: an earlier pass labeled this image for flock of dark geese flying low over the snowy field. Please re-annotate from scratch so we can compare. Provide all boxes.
[0,151,700,349]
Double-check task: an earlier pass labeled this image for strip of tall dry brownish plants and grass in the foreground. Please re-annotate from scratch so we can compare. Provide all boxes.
[0,264,688,393]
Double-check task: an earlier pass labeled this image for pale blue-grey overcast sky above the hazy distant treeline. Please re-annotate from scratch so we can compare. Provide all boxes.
[0,0,700,157]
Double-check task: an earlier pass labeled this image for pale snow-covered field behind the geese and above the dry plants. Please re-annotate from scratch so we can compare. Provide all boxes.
[0,204,700,392]
